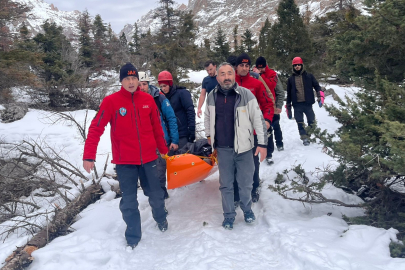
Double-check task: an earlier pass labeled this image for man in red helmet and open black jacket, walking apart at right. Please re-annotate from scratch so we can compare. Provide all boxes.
[286,57,323,146]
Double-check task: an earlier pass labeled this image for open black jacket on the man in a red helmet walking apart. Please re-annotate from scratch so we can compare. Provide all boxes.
[287,70,321,106]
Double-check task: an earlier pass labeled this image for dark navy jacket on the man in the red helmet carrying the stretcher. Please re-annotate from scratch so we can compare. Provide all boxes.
[165,85,195,138]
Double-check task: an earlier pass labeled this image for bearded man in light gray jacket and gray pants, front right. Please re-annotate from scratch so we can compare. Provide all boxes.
[204,63,267,230]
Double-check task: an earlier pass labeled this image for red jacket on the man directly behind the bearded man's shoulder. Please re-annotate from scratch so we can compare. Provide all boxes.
[235,73,274,123]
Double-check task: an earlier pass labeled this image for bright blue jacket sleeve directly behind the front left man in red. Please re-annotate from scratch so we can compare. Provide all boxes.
[149,85,179,145]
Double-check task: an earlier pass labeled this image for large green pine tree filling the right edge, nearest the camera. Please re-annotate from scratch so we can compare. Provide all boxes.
[306,0,405,253]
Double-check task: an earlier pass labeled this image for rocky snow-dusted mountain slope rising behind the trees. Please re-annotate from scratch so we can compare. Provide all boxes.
[122,0,362,44]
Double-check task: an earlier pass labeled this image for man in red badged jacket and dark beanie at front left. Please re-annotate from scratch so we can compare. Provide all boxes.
[83,63,168,249]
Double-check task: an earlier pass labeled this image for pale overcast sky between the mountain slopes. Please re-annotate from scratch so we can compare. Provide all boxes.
[45,0,188,33]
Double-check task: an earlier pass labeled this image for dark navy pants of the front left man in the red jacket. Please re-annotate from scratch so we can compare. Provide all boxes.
[116,160,166,245]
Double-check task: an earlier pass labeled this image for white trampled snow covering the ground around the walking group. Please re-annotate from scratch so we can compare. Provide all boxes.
[0,80,405,270]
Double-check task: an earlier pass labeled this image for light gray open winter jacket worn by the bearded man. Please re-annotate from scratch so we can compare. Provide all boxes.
[204,83,267,154]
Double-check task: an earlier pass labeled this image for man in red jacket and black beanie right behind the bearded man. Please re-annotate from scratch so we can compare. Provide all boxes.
[234,53,274,204]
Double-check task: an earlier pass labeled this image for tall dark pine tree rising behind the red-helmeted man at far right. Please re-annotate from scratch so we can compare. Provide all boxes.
[267,0,313,77]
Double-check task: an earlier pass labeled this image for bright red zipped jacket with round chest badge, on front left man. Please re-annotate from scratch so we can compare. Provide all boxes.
[83,87,168,165]
